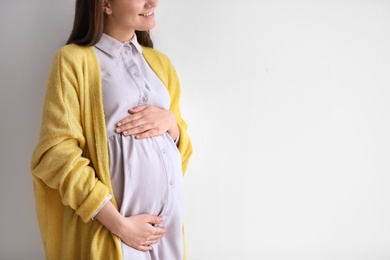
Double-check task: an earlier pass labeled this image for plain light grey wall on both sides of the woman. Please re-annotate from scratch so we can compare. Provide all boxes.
[0,0,390,260]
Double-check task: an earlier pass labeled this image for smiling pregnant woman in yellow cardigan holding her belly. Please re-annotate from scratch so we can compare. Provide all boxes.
[31,0,192,260]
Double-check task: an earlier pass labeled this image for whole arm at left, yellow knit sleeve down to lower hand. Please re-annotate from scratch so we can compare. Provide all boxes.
[31,48,165,250]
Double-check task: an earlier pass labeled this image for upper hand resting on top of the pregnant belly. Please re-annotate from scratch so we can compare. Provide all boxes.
[115,105,179,140]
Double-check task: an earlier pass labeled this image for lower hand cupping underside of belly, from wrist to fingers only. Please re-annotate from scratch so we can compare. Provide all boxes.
[118,214,165,251]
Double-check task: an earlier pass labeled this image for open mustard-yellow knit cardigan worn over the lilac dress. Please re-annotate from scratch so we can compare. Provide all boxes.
[31,44,192,260]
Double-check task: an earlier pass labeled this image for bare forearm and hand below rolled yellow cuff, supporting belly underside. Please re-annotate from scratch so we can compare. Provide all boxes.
[96,201,165,252]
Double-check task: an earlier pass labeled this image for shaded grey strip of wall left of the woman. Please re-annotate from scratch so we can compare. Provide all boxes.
[0,0,74,260]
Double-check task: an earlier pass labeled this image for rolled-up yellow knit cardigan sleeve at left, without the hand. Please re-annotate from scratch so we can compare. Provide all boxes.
[31,47,109,222]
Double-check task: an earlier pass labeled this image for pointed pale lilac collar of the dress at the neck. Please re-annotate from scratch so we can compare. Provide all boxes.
[95,33,142,58]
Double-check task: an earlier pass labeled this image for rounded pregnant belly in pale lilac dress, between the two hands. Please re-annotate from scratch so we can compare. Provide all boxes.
[109,134,181,216]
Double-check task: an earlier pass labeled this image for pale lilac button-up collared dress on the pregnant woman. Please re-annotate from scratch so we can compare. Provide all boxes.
[94,34,183,260]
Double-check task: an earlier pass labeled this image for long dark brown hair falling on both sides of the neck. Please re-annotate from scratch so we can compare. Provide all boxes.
[66,0,153,48]
